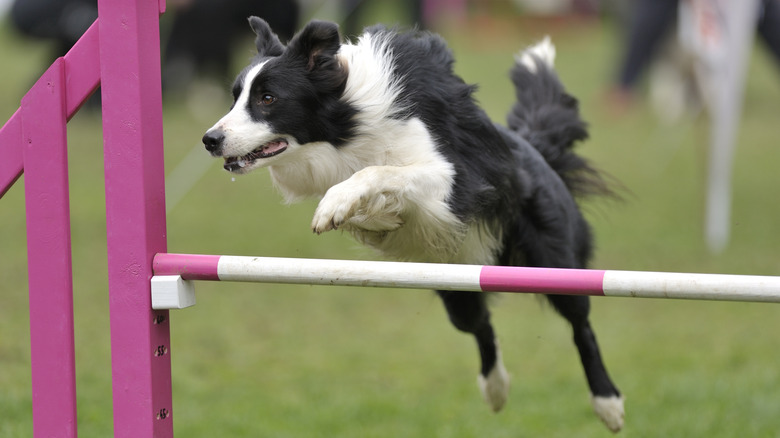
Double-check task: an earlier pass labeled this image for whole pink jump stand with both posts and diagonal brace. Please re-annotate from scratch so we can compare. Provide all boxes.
[0,0,173,438]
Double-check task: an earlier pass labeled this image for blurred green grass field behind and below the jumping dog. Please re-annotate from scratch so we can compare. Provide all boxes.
[0,1,780,438]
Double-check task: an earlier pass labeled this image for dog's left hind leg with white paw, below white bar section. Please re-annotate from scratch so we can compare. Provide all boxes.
[438,291,509,412]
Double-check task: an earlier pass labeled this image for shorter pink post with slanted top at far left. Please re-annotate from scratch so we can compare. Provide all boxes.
[20,58,76,437]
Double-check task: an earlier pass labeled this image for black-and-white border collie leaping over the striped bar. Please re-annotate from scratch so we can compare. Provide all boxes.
[203,17,624,431]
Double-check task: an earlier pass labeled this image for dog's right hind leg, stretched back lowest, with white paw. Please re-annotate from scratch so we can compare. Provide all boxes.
[547,295,624,432]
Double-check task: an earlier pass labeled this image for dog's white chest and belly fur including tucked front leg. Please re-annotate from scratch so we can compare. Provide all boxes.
[270,114,497,264]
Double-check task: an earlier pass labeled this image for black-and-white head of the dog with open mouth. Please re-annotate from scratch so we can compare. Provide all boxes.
[203,17,354,173]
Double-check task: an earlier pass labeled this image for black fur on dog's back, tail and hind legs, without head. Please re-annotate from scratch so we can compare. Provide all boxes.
[368,27,620,408]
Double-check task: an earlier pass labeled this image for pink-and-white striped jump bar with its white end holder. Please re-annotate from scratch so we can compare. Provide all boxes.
[152,253,780,309]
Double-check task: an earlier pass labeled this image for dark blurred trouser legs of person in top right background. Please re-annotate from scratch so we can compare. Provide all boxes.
[613,0,780,104]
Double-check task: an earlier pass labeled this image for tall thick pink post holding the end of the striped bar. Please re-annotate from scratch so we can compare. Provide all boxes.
[98,0,173,438]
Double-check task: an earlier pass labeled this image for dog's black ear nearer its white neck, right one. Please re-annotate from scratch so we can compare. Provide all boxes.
[288,20,341,71]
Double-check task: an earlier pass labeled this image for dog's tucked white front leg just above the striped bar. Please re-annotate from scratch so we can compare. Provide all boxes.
[312,166,451,234]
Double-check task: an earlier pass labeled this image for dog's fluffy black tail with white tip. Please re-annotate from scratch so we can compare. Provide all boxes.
[507,37,612,196]
